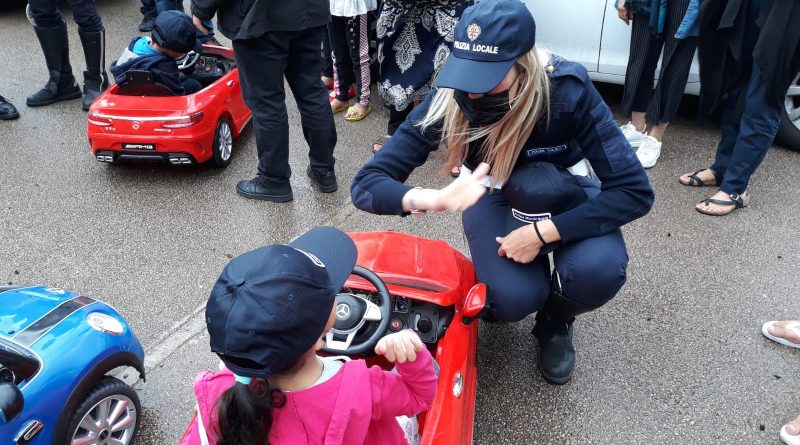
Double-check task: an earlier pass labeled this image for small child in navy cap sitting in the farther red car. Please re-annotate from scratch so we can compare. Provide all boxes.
[110,11,203,96]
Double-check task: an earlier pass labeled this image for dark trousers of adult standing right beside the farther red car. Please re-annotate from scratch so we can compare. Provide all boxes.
[233,26,336,182]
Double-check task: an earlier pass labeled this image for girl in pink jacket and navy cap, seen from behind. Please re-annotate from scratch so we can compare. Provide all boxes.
[181,227,437,445]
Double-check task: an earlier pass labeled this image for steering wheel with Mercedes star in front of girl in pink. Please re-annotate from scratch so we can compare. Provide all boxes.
[322,266,392,355]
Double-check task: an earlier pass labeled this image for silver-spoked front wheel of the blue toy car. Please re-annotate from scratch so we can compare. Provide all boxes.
[67,377,142,445]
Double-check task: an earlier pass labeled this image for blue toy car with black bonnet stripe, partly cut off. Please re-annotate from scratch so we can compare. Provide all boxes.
[0,286,144,445]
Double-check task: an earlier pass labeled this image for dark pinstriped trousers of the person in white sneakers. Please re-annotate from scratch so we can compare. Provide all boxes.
[622,0,697,125]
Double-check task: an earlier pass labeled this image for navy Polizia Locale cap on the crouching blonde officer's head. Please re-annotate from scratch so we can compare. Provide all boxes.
[436,0,536,94]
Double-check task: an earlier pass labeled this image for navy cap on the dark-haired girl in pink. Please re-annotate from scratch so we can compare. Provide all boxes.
[206,227,358,377]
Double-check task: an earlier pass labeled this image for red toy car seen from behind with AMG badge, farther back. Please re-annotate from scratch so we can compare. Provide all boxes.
[88,45,251,167]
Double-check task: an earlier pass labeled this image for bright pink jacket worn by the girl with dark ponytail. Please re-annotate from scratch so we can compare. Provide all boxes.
[180,349,436,445]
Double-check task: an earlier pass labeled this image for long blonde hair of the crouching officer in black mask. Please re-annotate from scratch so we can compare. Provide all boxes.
[419,46,550,183]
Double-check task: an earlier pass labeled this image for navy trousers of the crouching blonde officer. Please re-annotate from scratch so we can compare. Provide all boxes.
[462,177,628,321]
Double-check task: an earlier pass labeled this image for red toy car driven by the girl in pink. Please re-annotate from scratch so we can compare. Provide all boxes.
[182,232,486,445]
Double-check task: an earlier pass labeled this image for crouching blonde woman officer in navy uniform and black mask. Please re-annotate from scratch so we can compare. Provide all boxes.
[351,0,653,384]
